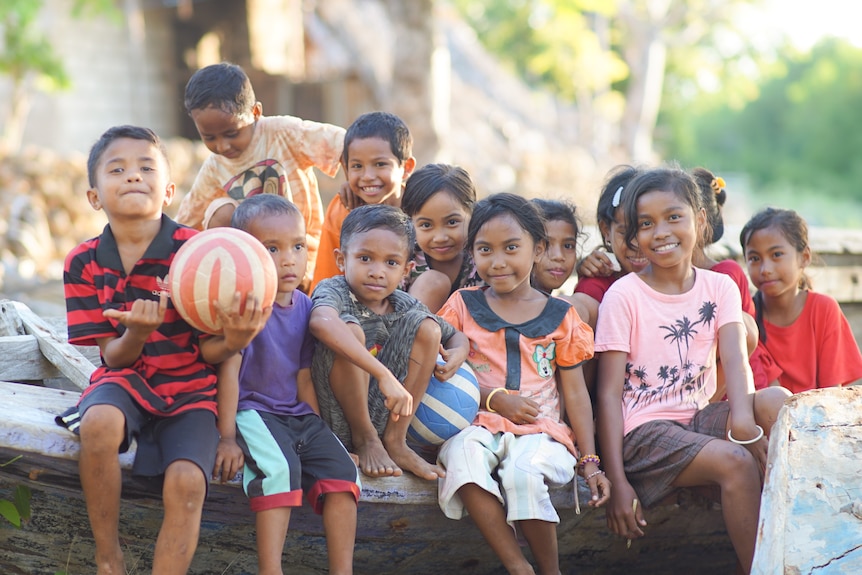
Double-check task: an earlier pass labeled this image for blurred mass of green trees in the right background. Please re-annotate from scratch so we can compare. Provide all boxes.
[665,39,862,223]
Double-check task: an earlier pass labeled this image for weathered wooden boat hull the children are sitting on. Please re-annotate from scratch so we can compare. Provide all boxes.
[0,304,735,575]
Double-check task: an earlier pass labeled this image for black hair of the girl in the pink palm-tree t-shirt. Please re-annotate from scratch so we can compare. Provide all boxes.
[623,166,712,247]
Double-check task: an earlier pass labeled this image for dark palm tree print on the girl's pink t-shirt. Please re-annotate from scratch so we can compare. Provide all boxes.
[623,301,716,409]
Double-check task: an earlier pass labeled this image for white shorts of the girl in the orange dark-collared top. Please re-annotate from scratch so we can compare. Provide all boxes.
[437,425,577,525]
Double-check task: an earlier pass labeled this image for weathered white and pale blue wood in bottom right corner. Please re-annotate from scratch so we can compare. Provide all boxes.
[752,387,862,575]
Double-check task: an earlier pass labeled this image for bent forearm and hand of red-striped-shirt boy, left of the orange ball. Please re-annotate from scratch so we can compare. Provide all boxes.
[96,292,168,368]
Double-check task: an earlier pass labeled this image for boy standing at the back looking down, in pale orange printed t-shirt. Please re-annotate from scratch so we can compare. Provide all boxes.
[177,62,344,290]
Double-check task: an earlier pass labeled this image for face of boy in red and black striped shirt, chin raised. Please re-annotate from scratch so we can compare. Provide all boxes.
[87,138,176,222]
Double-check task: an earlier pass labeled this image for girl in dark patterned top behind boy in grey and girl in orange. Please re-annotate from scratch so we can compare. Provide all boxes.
[401,164,482,313]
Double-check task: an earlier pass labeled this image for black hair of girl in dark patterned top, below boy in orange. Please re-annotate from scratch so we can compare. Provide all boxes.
[401,164,476,217]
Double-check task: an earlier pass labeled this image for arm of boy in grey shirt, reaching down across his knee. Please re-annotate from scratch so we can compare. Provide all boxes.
[308,306,413,420]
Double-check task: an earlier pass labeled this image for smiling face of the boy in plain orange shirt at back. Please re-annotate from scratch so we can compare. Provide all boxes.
[344,138,416,207]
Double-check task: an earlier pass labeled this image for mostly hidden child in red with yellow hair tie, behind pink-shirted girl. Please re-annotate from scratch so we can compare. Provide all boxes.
[691,168,781,392]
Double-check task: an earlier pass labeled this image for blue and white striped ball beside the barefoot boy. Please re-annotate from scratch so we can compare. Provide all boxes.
[407,356,480,445]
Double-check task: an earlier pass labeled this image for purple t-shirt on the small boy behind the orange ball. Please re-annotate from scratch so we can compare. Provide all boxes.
[237,290,314,415]
